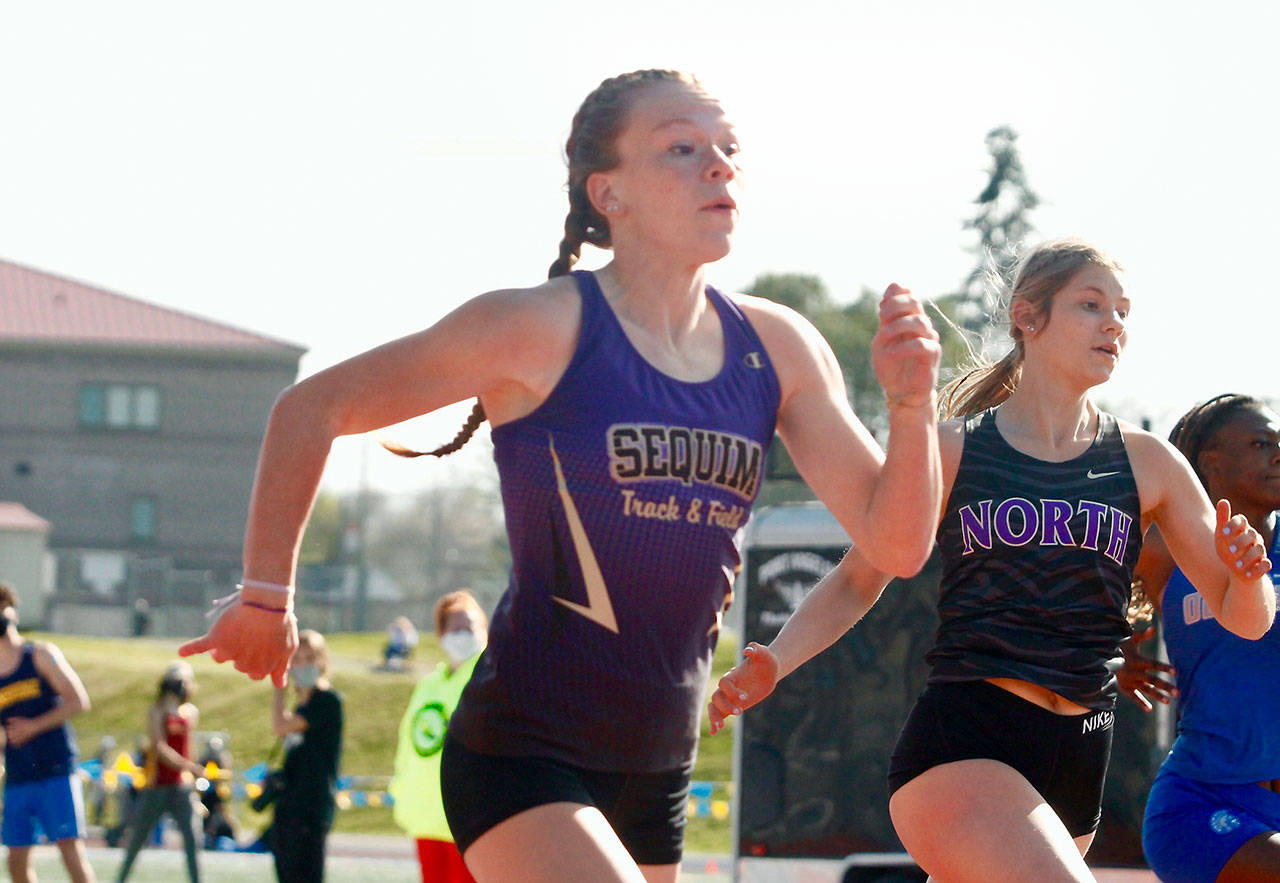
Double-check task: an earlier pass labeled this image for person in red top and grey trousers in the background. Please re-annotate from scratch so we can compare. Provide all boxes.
[116,662,205,883]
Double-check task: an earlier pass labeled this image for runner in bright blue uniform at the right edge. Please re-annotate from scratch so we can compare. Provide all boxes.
[1126,394,1280,883]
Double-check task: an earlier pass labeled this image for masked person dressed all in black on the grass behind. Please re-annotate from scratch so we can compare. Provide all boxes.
[270,628,342,883]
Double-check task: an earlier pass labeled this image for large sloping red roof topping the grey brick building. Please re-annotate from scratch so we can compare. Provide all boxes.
[0,255,306,356]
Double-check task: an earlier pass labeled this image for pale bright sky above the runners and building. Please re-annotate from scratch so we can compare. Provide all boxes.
[0,0,1280,490]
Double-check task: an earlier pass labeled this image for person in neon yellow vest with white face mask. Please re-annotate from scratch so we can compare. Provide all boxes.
[389,589,488,883]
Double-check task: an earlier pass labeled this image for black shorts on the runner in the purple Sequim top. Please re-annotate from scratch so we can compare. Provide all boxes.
[440,733,694,865]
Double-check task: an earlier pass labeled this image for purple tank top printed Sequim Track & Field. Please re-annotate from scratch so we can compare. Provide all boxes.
[449,271,780,773]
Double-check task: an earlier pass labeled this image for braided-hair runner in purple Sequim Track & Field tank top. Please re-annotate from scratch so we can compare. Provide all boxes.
[183,70,941,882]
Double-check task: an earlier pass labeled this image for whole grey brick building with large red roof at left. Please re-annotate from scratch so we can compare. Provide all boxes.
[0,255,306,627]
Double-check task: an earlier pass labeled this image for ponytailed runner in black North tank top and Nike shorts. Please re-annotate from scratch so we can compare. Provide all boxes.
[710,241,1275,882]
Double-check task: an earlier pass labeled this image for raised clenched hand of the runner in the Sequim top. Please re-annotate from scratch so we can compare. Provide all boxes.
[872,283,942,408]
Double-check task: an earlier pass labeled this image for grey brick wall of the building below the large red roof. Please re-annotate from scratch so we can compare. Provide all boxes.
[0,347,297,572]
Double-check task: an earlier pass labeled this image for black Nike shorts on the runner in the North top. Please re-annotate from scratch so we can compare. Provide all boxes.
[888,681,1115,837]
